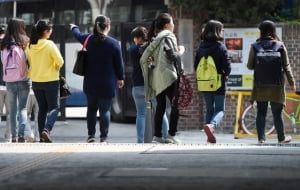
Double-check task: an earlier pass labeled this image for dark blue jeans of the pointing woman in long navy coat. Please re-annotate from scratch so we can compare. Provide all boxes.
[86,94,112,138]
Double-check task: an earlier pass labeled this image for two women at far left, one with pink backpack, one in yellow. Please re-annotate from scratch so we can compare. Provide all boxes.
[0,18,64,143]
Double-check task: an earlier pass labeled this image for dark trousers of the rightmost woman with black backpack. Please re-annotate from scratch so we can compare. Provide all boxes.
[256,102,285,141]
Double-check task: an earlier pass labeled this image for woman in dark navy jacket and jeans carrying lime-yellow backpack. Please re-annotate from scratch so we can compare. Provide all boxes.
[194,20,231,143]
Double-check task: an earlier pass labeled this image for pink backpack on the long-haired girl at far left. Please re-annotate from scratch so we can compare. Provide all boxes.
[2,45,28,82]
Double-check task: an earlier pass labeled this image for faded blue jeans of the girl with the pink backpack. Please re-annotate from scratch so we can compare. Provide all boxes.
[6,80,31,137]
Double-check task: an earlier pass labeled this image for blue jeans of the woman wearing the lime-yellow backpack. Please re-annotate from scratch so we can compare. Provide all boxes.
[203,92,225,127]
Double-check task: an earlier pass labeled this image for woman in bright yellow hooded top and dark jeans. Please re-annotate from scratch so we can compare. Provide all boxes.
[27,20,64,142]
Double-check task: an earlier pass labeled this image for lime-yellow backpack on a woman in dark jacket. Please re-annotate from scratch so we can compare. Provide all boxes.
[196,56,222,92]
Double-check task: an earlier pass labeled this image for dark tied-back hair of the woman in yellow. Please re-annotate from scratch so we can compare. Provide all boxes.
[29,19,52,47]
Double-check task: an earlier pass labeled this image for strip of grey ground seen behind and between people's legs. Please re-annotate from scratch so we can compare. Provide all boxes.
[22,119,300,144]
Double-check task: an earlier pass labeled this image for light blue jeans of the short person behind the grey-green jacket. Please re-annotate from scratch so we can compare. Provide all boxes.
[132,86,169,143]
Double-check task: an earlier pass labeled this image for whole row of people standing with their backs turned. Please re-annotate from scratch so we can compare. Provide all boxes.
[0,13,296,144]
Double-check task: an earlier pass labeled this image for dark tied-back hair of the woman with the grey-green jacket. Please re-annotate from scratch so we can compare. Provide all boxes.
[148,13,172,41]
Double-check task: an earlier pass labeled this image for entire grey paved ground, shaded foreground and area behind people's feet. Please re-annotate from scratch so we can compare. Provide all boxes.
[0,119,300,190]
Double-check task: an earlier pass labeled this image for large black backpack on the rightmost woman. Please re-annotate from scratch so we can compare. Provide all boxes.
[253,41,284,87]
